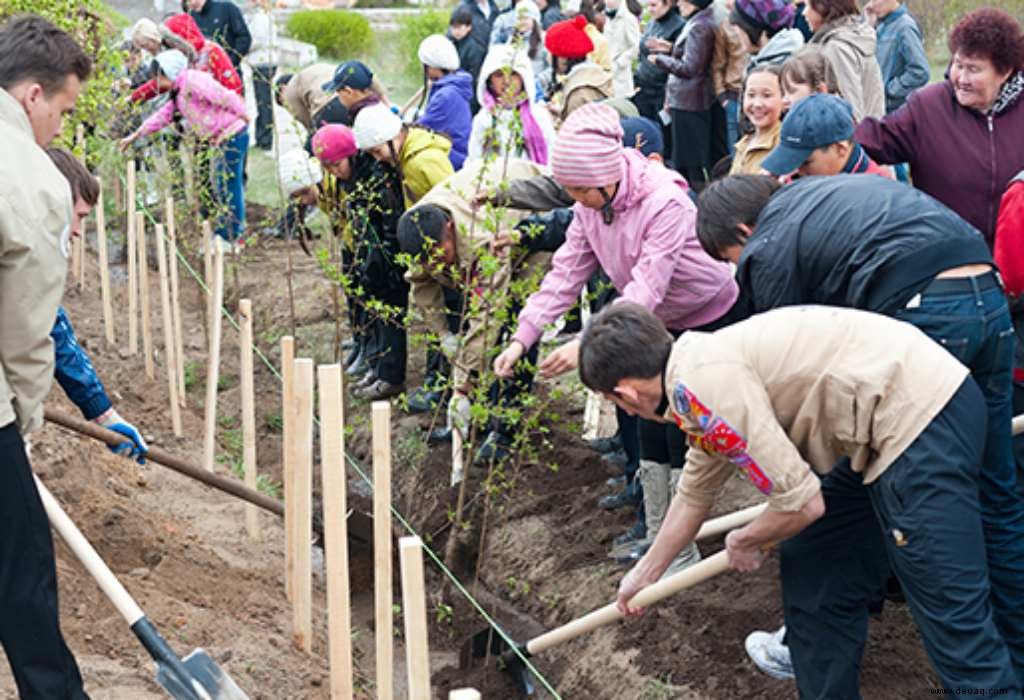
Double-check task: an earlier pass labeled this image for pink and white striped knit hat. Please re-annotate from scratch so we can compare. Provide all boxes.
[551,102,626,187]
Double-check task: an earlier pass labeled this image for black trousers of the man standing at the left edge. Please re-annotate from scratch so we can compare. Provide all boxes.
[0,423,88,700]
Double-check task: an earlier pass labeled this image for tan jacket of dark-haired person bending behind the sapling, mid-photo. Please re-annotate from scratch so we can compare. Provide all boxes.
[406,159,550,386]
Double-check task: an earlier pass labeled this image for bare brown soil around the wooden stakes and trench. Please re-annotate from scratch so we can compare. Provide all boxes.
[0,208,936,699]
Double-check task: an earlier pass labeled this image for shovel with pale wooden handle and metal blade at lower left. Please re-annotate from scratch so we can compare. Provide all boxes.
[36,477,249,700]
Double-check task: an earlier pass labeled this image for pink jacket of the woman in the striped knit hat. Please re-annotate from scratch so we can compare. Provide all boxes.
[513,148,739,348]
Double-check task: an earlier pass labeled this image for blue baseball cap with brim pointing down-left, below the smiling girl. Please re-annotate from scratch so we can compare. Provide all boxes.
[761,93,854,175]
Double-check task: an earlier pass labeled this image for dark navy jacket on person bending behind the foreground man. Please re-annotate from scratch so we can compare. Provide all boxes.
[736,175,992,314]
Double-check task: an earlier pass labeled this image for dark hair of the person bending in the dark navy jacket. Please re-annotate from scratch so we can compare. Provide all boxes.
[697,175,782,260]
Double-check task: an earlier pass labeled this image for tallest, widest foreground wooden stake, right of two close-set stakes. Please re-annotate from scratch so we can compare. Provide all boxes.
[316,364,354,700]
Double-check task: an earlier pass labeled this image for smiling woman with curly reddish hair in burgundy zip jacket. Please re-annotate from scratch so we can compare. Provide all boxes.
[854,8,1024,248]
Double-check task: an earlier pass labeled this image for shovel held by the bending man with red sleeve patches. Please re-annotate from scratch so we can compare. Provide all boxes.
[460,504,767,695]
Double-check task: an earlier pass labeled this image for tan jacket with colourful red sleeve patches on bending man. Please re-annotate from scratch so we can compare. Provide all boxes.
[665,306,968,512]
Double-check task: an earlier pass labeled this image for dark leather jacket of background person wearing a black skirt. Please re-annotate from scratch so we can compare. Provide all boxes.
[654,7,715,112]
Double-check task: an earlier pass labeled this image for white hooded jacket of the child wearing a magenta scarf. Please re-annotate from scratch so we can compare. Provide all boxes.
[468,44,555,160]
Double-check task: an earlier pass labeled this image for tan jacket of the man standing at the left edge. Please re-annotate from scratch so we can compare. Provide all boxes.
[0,89,72,434]
